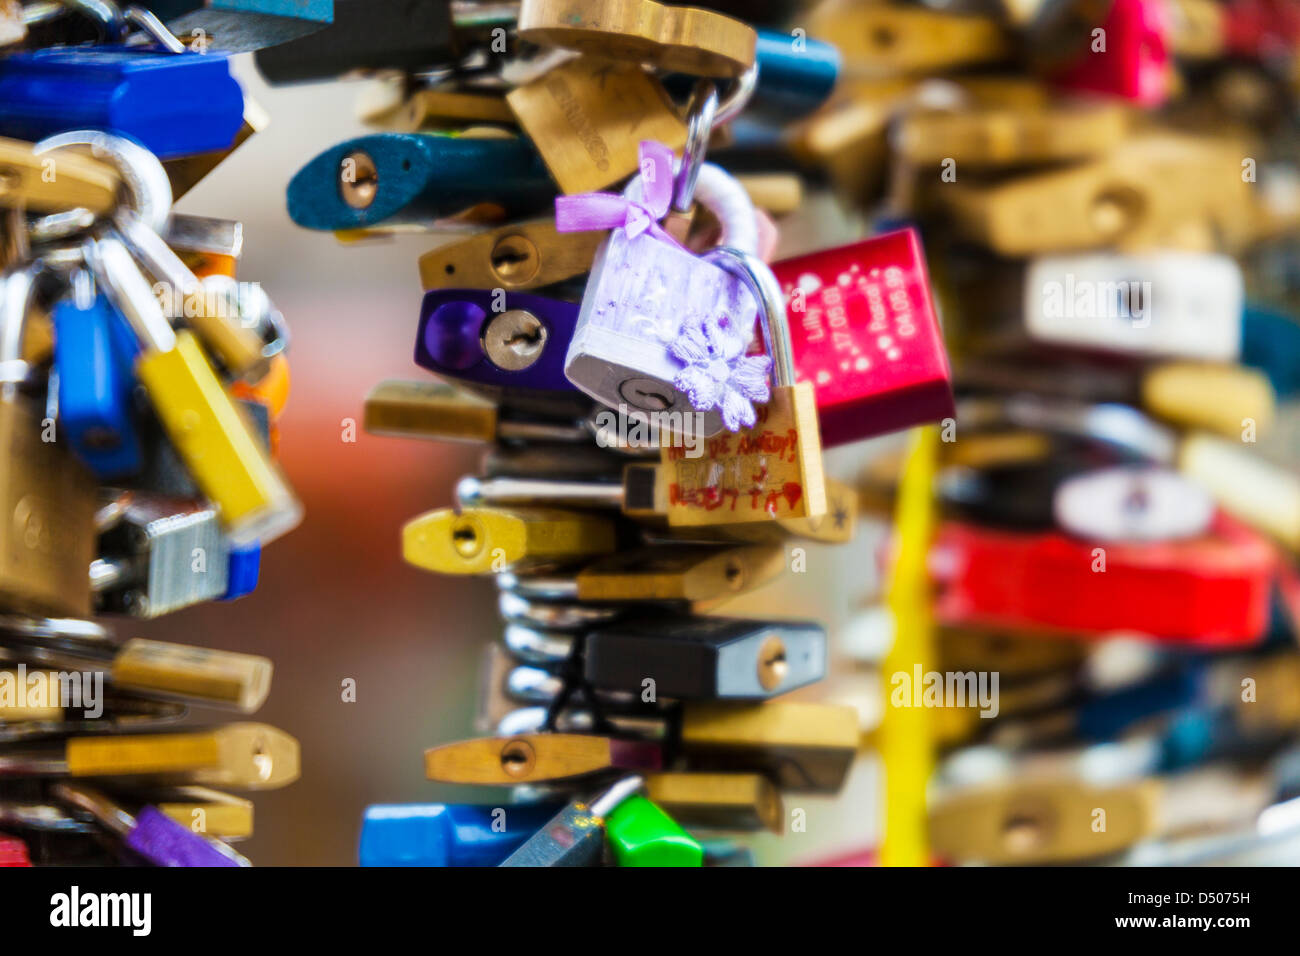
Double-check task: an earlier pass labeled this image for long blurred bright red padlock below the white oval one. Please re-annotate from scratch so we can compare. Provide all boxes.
[930,515,1278,646]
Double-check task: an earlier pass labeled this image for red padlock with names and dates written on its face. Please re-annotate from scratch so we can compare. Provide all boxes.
[772,229,956,447]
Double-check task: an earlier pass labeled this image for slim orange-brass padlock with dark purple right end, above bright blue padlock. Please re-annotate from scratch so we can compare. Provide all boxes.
[426,734,663,786]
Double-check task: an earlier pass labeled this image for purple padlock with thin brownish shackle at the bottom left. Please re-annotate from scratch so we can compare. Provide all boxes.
[51,783,251,866]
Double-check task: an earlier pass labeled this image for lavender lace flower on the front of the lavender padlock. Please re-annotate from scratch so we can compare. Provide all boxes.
[668,317,772,432]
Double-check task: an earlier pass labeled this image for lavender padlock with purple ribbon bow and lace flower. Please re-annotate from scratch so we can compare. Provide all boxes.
[555,142,770,436]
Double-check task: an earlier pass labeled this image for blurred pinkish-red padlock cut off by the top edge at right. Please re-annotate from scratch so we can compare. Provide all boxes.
[1056,0,1173,107]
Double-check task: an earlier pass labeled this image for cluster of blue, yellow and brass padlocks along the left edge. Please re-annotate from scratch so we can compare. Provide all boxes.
[0,0,309,866]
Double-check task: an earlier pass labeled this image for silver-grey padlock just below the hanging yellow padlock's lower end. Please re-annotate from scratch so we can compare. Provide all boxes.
[96,494,230,618]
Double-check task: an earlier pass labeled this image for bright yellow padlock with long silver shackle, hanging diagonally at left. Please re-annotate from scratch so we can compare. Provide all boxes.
[92,238,302,545]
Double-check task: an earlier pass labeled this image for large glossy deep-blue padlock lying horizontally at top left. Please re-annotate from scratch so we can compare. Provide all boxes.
[0,47,244,160]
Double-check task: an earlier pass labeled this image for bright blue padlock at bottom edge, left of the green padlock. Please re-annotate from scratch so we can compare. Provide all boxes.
[360,803,564,866]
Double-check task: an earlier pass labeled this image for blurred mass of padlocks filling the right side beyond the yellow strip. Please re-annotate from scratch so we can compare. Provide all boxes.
[816,0,1300,865]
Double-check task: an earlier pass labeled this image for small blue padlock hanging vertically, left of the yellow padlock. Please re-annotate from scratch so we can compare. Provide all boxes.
[51,289,143,479]
